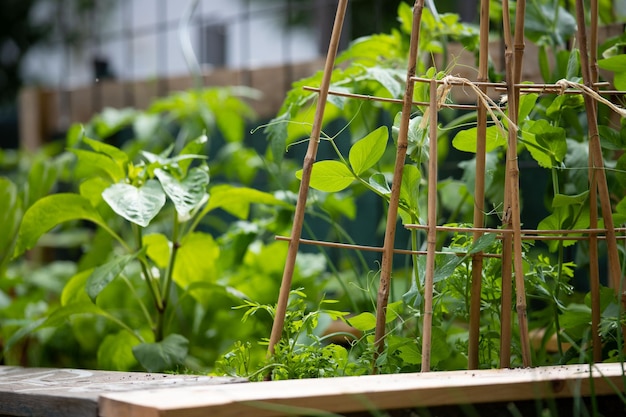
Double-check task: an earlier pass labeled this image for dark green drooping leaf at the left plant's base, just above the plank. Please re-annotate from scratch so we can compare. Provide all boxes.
[132,334,189,372]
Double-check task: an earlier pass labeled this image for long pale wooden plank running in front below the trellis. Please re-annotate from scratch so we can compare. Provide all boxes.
[100,364,624,417]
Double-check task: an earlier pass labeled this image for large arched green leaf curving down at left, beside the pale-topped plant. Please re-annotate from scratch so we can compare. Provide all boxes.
[14,194,106,256]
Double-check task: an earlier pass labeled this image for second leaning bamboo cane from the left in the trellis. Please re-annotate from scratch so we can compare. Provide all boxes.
[373,0,424,373]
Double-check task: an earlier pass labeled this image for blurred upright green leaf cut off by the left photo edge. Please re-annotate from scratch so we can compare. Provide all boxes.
[0,177,22,268]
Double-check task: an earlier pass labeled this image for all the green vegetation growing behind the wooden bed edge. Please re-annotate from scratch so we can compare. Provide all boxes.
[0,1,626,404]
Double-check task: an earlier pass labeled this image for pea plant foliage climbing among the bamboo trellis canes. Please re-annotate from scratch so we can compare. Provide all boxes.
[249,2,626,372]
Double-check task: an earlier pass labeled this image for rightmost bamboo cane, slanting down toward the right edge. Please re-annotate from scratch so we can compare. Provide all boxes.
[576,0,626,352]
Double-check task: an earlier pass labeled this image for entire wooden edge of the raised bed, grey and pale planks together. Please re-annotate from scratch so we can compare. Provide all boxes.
[0,363,626,417]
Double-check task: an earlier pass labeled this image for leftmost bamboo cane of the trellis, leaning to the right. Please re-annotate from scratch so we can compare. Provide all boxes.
[268,0,348,356]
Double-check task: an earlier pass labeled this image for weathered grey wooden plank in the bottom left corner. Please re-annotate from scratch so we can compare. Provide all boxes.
[0,366,244,417]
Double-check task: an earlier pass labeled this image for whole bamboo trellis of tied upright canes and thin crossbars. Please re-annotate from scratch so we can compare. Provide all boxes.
[268,0,626,373]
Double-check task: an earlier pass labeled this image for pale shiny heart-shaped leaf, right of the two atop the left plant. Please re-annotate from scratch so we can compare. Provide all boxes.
[154,167,209,219]
